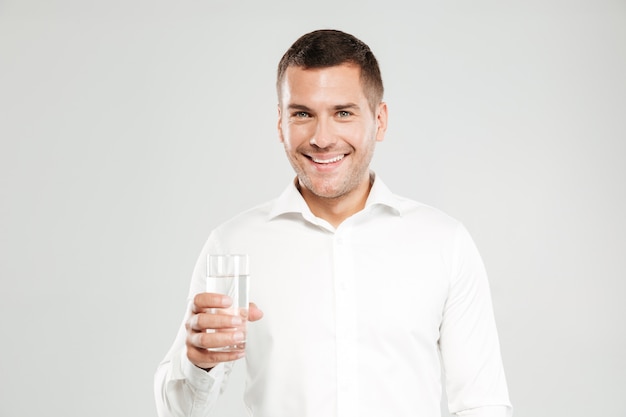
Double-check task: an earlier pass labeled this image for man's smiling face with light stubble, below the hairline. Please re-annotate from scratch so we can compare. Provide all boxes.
[278,64,387,203]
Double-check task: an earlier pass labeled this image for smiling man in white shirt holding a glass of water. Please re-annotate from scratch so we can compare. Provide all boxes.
[155,30,511,417]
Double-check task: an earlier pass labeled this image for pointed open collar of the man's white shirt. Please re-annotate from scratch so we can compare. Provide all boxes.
[269,172,407,219]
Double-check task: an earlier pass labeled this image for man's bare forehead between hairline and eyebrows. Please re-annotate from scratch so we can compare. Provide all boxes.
[281,64,365,103]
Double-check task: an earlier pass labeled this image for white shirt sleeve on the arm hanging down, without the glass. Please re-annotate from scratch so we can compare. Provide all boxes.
[439,225,512,417]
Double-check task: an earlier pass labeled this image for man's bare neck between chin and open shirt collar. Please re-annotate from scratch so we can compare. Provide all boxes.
[296,176,372,228]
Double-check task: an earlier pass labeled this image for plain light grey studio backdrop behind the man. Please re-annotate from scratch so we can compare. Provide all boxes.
[0,0,626,417]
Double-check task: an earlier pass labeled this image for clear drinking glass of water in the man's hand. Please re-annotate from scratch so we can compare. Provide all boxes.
[206,254,250,352]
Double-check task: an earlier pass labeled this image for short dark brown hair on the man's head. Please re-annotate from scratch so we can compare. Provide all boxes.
[276,29,384,112]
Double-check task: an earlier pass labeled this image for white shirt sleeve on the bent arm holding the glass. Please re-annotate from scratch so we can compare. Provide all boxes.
[154,232,233,417]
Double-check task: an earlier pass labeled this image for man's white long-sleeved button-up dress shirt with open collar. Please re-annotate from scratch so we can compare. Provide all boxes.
[155,174,511,417]
